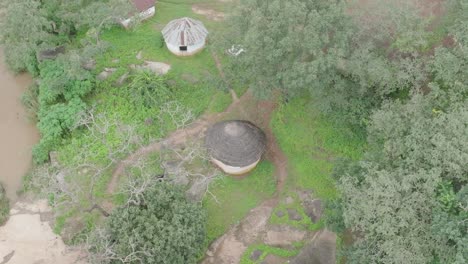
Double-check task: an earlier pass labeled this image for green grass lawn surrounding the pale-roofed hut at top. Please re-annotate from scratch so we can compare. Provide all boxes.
[95,0,236,114]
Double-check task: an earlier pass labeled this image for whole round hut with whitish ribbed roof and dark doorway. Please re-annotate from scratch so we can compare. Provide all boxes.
[161,17,208,56]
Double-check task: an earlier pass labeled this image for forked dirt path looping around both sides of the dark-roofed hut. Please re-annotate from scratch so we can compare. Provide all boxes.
[104,54,288,264]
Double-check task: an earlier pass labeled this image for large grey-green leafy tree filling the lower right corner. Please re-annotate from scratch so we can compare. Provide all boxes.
[332,95,468,263]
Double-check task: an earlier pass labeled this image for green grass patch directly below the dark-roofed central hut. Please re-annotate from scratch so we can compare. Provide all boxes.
[203,161,276,242]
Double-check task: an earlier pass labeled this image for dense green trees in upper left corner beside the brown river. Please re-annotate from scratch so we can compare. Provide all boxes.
[0,0,134,163]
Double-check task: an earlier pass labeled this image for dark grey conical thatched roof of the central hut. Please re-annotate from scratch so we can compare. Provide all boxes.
[205,120,266,167]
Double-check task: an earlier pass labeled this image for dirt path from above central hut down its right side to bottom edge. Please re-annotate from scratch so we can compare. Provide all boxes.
[202,94,288,264]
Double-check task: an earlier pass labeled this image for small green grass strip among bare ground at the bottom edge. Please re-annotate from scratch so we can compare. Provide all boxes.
[240,243,303,264]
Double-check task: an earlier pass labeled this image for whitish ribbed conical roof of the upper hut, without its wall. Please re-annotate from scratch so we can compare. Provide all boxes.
[161,17,208,46]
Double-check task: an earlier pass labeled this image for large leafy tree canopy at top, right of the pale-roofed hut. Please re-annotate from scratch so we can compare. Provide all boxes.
[219,0,434,126]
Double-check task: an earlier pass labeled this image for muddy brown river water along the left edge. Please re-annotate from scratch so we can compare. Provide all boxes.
[0,50,39,201]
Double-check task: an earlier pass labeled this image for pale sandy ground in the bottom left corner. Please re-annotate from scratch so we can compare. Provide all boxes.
[0,200,86,264]
